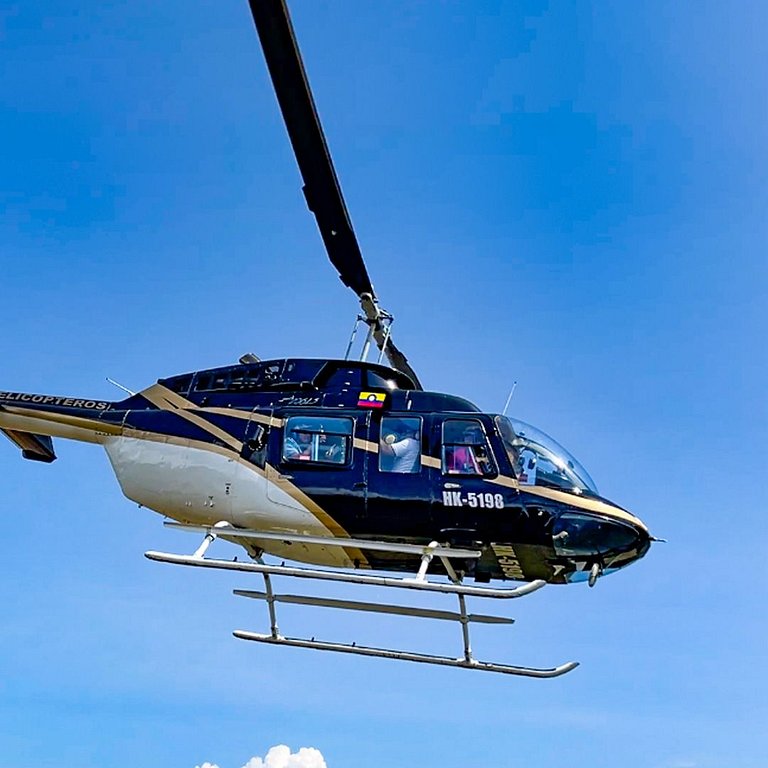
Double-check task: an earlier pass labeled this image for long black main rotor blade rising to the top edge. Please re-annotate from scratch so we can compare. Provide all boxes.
[249,0,375,297]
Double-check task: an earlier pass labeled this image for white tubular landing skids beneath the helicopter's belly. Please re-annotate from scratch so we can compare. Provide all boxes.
[145,523,578,677]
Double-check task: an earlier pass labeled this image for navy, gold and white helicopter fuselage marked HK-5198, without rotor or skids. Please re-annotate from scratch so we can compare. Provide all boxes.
[0,359,650,583]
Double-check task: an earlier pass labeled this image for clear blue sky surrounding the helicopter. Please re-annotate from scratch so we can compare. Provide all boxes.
[0,0,768,768]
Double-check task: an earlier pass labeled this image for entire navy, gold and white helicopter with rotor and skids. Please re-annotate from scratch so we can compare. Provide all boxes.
[0,0,655,678]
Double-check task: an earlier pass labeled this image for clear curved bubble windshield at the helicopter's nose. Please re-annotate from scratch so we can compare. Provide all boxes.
[496,416,599,496]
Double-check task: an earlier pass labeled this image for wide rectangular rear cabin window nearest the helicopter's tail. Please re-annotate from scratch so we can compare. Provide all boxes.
[282,416,354,466]
